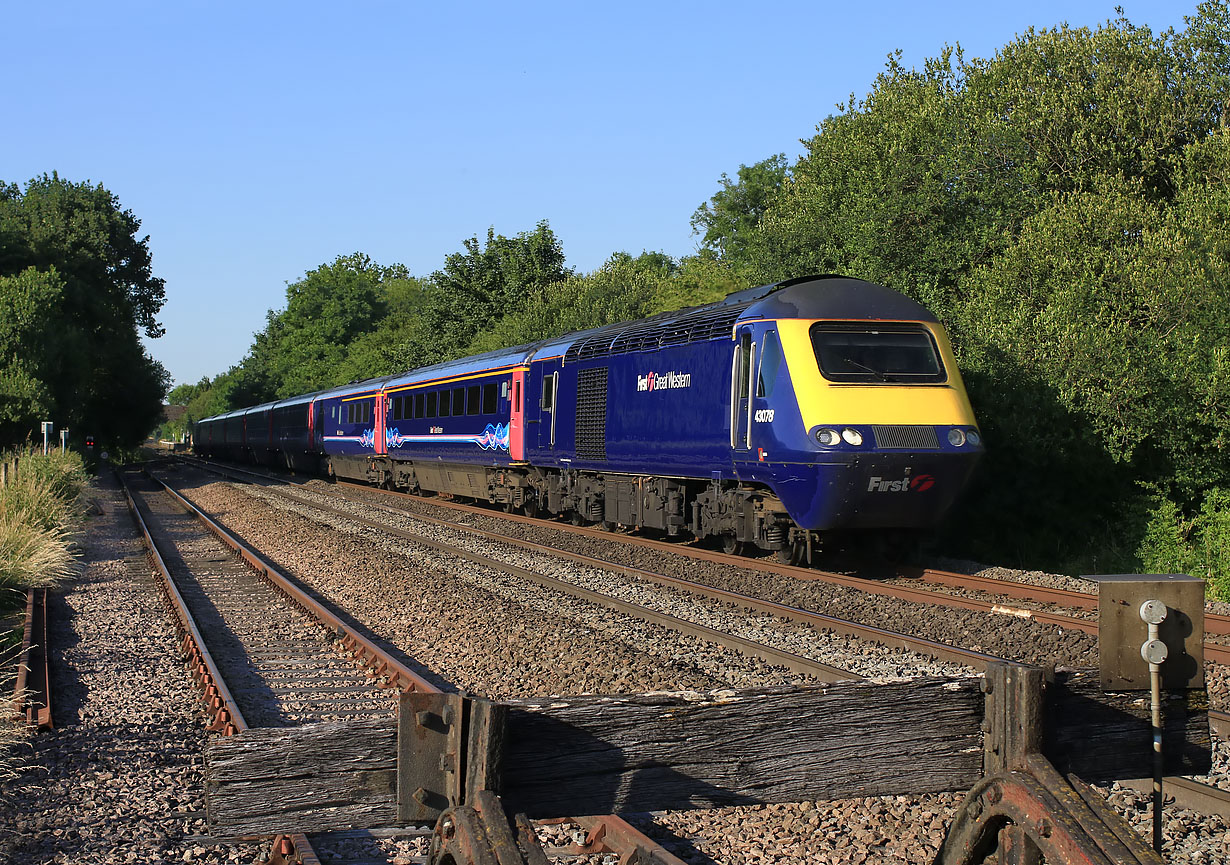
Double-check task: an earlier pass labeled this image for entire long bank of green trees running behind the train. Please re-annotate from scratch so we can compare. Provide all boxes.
[172,0,1230,597]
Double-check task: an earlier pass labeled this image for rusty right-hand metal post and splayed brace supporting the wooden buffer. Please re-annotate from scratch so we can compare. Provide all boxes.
[936,664,1162,865]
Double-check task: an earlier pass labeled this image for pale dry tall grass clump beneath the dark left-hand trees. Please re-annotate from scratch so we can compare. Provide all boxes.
[0,452,89,593]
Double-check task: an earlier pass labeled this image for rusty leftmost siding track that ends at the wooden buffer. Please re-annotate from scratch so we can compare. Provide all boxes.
[121,474,683,865]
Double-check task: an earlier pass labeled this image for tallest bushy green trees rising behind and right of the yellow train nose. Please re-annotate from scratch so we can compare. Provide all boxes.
[732,0,1230,580]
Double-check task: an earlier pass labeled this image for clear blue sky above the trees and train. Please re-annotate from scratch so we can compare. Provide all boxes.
[0,0,1196,384]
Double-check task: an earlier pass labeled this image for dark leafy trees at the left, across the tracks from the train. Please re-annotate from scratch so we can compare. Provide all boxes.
[0,173,169,447]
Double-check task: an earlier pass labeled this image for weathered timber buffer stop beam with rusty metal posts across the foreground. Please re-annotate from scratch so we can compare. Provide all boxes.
[207,581,1212,865]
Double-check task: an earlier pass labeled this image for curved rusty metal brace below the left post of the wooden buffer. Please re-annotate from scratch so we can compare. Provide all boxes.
[428,790,547,865]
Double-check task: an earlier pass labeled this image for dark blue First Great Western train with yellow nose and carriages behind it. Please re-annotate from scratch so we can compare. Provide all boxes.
[194,276,983,560]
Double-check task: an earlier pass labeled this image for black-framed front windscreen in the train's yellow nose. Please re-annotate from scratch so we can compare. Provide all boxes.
[812,321,948,384]
